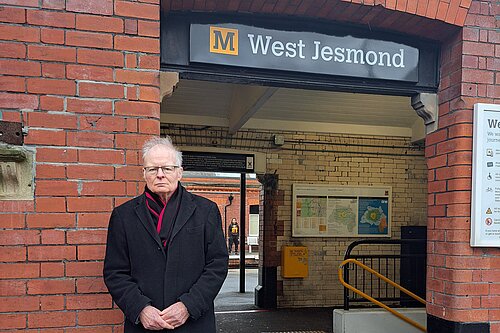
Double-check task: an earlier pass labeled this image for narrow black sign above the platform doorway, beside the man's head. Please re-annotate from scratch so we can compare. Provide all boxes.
[182,151,255,173]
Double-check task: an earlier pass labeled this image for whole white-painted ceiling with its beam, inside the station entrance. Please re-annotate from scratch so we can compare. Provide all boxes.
[161,80,422,138]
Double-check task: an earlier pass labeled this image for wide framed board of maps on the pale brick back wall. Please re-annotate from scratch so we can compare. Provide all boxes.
[292,184,392,237]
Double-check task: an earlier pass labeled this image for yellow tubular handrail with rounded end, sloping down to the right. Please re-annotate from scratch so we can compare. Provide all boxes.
[338,259,427,332]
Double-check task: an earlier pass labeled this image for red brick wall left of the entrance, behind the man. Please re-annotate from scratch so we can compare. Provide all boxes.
[0,0,160,333]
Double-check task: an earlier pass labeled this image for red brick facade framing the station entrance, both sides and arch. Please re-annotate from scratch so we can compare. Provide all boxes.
[0,0,500,333]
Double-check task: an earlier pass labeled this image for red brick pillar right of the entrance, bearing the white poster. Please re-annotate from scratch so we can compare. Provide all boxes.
[426,1,500,333]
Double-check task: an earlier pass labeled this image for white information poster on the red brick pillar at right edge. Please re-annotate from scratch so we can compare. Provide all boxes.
[470,104,500,247]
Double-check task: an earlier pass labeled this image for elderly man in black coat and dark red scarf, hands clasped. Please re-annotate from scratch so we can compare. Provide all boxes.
[104,138,228,333]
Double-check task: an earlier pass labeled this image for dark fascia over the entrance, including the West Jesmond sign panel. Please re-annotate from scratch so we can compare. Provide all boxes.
[160,12,439,96]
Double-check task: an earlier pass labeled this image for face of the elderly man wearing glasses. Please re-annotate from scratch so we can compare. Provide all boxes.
[143,145,182,200]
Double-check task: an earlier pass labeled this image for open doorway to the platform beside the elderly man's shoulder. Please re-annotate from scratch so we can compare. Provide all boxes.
[183,171,261,312]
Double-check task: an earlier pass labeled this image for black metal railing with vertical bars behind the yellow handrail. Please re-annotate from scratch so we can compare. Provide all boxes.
[343,239,426,310]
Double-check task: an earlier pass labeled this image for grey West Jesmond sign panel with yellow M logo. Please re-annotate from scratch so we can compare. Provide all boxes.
[189,23,419,82]
